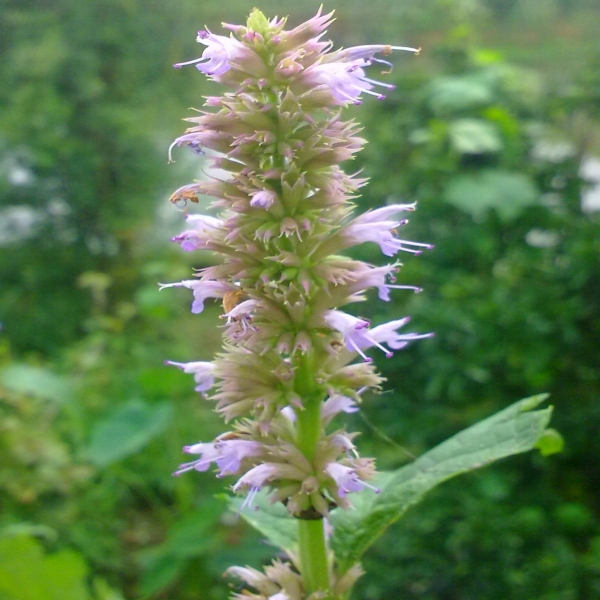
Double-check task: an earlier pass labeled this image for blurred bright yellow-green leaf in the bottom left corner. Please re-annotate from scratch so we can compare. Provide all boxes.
[0,536,90,600]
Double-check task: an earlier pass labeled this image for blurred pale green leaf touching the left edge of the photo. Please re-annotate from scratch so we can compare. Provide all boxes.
[0,364,73,402]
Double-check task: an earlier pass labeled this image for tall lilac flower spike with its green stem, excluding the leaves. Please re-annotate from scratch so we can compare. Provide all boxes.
[161,10,560,600]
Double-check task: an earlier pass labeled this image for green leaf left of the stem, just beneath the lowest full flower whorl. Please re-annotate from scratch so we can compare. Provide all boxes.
[228,490,298,551]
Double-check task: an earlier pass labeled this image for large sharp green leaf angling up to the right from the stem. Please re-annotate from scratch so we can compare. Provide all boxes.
[331,394,552,572]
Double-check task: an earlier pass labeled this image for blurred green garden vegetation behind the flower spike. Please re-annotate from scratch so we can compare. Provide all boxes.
[0,0,600,600]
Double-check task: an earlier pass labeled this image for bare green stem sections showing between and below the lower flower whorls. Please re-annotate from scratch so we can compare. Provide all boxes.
[296,354,331,595]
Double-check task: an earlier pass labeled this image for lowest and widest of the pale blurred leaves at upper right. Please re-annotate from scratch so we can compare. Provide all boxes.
[444,169,538,221]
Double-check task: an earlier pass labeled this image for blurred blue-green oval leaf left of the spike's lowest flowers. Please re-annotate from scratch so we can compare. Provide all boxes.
[84,400,172,467]
